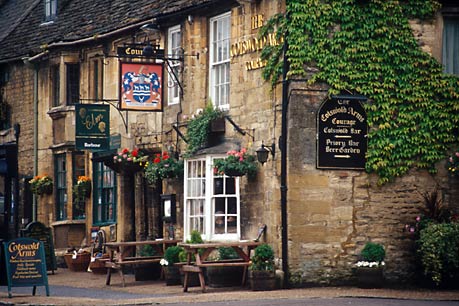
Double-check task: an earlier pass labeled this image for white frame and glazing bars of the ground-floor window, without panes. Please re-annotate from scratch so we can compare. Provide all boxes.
[183,155,241,241]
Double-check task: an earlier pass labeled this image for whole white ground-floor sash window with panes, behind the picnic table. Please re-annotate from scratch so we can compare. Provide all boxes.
[184,156,240,240]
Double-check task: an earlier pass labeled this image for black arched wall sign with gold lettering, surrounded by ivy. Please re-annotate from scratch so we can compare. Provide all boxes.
[317,95,368,170]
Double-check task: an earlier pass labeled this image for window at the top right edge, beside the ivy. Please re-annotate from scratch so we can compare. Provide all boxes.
[442,16,459,75]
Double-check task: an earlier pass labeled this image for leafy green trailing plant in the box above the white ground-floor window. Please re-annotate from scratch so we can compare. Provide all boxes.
[186,103,224,155]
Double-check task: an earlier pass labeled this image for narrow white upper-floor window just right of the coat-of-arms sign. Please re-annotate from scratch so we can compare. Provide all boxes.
[167,25,182,105]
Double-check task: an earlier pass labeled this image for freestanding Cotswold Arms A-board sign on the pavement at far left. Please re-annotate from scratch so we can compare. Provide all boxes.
[2,238,49,297]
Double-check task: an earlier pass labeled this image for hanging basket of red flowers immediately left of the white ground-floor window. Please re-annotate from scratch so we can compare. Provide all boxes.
[145,152,183,184]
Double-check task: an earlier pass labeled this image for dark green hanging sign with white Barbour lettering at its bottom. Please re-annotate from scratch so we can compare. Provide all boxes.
[75,104,110,151]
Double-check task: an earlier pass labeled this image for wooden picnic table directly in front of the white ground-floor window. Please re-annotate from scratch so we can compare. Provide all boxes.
[177,240,261,292]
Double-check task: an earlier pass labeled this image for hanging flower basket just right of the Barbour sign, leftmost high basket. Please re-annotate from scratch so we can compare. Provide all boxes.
[107,148,148,174]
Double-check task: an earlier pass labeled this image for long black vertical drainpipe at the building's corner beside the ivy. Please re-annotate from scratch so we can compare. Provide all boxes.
[280,35,290,288]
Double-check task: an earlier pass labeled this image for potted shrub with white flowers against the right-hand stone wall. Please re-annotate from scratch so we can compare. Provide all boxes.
[355,242,386,288]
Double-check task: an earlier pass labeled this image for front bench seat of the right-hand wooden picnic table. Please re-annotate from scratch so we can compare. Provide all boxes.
[182,259,250,292]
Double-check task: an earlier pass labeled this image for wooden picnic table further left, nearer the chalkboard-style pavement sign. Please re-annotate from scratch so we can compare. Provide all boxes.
[104,239,180,287]
